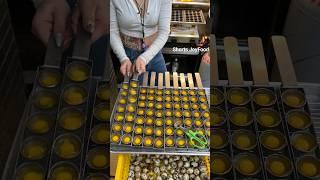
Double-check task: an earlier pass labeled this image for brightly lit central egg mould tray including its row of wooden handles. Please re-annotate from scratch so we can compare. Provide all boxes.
[110,72,210,155]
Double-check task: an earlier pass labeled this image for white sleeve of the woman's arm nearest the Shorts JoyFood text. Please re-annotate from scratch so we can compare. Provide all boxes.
[139,0,172,64]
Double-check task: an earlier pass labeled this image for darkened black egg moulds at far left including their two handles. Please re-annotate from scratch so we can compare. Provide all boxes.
[3,32,111,179]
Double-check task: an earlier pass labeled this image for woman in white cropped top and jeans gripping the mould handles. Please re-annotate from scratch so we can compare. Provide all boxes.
[110,0,172,76]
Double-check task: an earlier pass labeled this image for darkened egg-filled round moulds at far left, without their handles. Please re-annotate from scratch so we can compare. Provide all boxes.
[14,61,109,180]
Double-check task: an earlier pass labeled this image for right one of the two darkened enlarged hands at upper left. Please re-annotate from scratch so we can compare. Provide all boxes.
[72,0,109,41]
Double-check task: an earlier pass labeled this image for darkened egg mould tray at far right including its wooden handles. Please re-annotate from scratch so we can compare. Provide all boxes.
[210,36,320,179]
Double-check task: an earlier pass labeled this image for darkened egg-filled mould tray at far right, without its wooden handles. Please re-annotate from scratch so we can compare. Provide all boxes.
[210,87,320,179]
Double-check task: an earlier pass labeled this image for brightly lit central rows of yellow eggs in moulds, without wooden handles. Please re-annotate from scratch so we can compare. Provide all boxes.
[111,81,210,148]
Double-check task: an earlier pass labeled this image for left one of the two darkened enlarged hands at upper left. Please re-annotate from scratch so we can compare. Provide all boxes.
[32,0,72,47]
